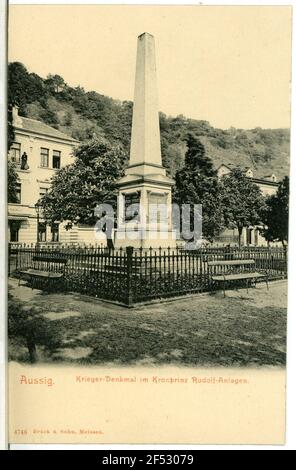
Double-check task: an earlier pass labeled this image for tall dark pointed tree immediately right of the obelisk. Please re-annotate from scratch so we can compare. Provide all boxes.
[173,133,224,241]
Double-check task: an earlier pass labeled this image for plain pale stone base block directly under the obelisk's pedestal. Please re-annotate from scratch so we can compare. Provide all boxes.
[114,228,176,249]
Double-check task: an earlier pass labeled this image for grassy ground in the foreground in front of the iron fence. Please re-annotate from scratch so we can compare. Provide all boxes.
[9,279,287,366]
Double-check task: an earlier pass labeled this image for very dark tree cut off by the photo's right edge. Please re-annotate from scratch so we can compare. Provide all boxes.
[263,176,289,246]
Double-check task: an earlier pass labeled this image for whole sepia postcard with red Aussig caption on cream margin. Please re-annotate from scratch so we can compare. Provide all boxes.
[7,5,292,444]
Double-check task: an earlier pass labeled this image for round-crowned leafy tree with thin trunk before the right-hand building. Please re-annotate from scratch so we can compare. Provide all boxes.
[221,168,265,246]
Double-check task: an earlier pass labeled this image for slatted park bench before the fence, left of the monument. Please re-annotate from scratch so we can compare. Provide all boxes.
[19,254,68,289]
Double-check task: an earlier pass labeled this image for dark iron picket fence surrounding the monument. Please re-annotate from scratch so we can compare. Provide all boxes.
[8,244,287,306]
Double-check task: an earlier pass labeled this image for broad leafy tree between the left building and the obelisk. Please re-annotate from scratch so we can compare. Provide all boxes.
[41,136,126,229]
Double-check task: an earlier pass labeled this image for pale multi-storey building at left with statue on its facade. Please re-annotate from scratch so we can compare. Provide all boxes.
[8,107,78,244]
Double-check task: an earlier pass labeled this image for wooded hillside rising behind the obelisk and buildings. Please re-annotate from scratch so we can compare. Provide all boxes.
[8,62,290,179]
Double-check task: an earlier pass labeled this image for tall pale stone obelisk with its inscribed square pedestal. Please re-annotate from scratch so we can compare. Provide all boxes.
[115,33,176,248]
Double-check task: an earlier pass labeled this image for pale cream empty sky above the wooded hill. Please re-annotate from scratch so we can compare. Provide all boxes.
[8,5,291,129]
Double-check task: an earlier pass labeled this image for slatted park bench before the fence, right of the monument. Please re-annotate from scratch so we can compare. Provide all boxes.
[208,259,269,297]
